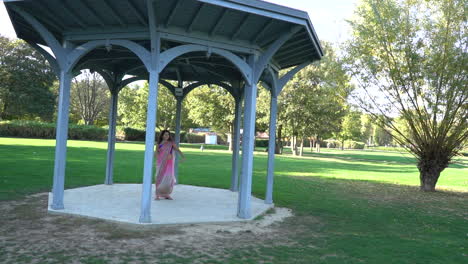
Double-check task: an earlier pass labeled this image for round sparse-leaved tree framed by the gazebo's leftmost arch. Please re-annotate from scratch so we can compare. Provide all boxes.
[70,71,109,125]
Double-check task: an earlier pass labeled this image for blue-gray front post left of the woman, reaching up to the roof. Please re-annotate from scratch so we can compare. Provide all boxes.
[139,0,161,223]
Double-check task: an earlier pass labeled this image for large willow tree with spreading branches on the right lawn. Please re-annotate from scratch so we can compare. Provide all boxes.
[347,0,468,191]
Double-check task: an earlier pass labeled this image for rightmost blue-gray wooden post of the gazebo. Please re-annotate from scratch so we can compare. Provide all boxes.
[265,94,278,204]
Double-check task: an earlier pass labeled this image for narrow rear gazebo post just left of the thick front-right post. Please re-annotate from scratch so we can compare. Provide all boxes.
[230,96,242,192]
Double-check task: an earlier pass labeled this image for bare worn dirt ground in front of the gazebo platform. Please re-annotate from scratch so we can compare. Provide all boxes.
[0,193,320,264]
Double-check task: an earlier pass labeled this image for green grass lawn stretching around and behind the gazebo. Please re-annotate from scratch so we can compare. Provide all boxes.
[0,138,468,263]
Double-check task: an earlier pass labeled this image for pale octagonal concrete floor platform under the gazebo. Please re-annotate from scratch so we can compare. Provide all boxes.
[48,184,273,225]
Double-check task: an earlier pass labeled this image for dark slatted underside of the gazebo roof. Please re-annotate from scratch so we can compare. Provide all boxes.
[4,0,323,81]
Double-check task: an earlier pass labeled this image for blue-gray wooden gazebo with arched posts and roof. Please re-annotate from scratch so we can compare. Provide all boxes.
[3,0,323,223]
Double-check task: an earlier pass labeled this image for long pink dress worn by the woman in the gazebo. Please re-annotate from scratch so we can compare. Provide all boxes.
[155,142,176,197]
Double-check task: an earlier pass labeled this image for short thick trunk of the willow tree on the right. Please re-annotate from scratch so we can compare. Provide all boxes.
[418,158,449,192]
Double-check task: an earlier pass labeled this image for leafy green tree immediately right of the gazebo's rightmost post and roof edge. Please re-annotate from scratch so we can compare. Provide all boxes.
[278,42,353,154]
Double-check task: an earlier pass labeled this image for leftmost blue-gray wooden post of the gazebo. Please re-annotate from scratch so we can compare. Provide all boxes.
[51,71,72,210]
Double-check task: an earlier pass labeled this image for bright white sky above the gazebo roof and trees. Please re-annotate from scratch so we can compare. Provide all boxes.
[0,0,359,43]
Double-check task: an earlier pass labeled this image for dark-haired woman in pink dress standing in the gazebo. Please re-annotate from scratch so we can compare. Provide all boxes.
[155,130,185,200]
